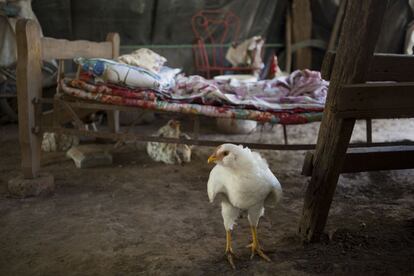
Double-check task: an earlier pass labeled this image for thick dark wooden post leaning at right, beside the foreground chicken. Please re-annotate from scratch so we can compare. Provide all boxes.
[298,0,388,241]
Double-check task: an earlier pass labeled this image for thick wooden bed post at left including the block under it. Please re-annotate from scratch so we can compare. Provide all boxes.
[8,20,54,197]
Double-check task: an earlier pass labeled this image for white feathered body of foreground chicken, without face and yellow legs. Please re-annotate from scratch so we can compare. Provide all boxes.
[207,144,282,229]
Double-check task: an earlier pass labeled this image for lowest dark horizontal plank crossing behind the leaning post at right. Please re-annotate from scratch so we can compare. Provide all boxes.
[302,146,414,176]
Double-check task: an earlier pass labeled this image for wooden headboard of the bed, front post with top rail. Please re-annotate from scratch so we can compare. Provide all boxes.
[16,19,120,178]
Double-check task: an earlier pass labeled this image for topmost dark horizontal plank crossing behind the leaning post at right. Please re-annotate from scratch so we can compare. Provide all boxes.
[322,51,414,82]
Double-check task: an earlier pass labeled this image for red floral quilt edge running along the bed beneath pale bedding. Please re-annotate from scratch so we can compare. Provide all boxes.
[60,79,322,124]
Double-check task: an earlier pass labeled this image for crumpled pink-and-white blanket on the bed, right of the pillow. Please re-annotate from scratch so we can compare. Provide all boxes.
[167,70,329,111]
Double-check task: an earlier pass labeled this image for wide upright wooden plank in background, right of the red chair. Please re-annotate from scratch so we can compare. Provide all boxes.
[292,0,312,69]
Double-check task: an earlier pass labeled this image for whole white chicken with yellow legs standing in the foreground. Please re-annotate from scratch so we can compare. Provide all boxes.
[207,144,282,268]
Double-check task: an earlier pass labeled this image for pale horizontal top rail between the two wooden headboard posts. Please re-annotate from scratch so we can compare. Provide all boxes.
[42,37,113,60]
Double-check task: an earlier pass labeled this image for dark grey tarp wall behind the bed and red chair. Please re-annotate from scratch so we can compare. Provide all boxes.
[33,0,413,73]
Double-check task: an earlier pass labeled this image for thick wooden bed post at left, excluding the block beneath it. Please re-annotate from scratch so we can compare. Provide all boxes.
[16,20,42,178]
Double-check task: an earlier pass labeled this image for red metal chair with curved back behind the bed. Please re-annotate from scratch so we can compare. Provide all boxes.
[191,10,257,78]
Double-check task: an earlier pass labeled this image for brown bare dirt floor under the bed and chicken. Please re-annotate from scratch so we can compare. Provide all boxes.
[0,117,414,275]
